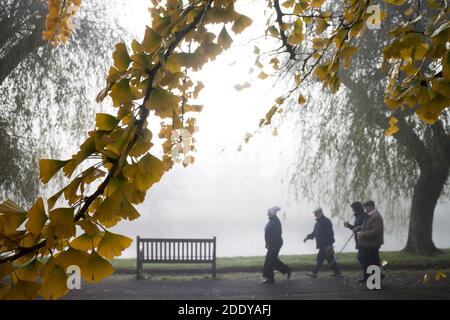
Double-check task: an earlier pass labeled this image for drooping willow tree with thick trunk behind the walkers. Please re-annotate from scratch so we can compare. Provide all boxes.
[291,0,450,255]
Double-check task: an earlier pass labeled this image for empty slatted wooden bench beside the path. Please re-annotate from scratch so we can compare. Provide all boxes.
[136,236,216,280]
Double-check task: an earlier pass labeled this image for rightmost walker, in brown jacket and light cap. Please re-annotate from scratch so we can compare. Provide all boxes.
[354,200,384,283]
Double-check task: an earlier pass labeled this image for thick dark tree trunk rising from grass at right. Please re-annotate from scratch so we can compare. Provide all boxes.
[403,164,449,255]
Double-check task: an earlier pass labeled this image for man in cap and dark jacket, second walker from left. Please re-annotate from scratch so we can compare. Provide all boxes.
[303,208,341,278]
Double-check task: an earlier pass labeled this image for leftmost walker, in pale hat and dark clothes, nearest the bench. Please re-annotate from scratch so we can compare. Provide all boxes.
[263,206,292,284]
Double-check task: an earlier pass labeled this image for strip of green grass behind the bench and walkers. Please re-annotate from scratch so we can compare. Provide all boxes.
[112,249,450,273]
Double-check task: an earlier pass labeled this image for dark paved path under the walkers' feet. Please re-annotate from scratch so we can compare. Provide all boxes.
[65,270,450,300]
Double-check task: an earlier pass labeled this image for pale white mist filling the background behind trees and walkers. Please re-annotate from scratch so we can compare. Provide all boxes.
[0,0,450,258]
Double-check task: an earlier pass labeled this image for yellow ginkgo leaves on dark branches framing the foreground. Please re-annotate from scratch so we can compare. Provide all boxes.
[0,0,450,299]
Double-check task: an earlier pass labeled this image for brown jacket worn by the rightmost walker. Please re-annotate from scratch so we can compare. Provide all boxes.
[355,210,384,248]
